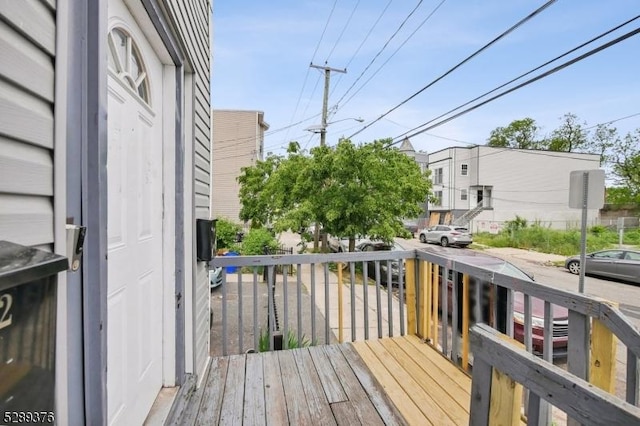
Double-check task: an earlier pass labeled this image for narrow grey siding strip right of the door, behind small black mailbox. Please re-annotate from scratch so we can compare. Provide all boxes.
[168,0,211,376]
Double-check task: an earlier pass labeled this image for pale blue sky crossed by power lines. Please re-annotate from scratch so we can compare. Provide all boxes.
[211,0,640,154]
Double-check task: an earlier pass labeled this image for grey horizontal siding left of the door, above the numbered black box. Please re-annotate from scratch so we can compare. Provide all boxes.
[0,0,55,249]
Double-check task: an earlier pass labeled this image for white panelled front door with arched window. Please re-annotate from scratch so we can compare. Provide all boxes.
[107,2,163,425]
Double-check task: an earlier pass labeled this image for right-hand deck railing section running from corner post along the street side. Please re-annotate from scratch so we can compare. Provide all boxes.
[416,251,640,424]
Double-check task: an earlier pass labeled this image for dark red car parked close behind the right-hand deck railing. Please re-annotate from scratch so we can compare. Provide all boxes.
[429,247,569,357]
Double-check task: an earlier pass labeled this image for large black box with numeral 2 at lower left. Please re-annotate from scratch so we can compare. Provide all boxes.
[0,241,68,415]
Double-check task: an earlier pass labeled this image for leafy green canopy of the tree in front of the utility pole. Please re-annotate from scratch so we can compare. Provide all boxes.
[238,139,431,250]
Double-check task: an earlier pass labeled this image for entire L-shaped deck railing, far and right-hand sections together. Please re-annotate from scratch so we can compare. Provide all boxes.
[212,246,640,424]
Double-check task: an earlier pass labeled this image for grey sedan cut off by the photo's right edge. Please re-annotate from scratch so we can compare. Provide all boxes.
[564,249,640,284]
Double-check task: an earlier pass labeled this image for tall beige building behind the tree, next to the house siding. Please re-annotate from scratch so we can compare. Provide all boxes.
[211,109,269,222]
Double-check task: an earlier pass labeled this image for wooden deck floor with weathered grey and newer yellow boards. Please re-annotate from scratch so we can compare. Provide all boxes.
[179,336,471,425]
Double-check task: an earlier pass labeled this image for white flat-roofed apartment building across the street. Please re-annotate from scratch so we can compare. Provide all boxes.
[428,146,600,232]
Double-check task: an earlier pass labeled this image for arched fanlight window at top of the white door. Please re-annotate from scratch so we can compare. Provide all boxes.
[109,28,151,105]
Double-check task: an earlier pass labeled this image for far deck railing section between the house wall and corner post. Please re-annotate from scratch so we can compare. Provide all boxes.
[211,251,415,355]
